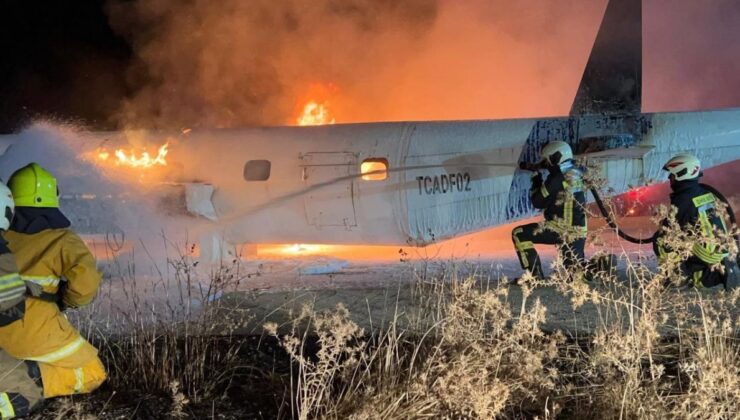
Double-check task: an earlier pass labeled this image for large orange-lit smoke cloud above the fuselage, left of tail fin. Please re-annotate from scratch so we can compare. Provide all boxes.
[108,0,606,128]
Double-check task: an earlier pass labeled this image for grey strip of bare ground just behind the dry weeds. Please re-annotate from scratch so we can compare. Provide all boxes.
[223,261,732,339]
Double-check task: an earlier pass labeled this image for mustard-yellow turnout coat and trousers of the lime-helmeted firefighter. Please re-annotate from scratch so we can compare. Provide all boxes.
[0,229,106,398]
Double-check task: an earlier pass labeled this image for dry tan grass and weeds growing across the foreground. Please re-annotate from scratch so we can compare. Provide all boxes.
[31,185,740,420]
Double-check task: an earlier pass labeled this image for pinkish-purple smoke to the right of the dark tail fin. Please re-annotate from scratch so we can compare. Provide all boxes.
[643,0,740,112]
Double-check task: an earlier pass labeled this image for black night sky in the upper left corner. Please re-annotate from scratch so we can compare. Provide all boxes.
[0,0,130,133]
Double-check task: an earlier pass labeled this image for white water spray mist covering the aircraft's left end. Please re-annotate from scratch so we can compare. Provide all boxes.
[0,121,214,270]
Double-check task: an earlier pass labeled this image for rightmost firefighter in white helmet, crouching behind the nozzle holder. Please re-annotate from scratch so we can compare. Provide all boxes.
[653,153,737,289]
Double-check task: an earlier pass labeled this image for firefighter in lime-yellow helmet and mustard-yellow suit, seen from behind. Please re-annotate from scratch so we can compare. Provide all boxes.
[0,163,106,419]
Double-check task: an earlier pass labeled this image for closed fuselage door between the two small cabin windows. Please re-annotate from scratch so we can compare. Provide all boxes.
[301,152,357,229]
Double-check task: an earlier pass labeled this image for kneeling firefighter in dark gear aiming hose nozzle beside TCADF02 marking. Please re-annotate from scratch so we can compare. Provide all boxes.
[511,141,587,284]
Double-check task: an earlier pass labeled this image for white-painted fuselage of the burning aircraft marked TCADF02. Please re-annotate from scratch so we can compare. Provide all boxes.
[0,109,740,262]
